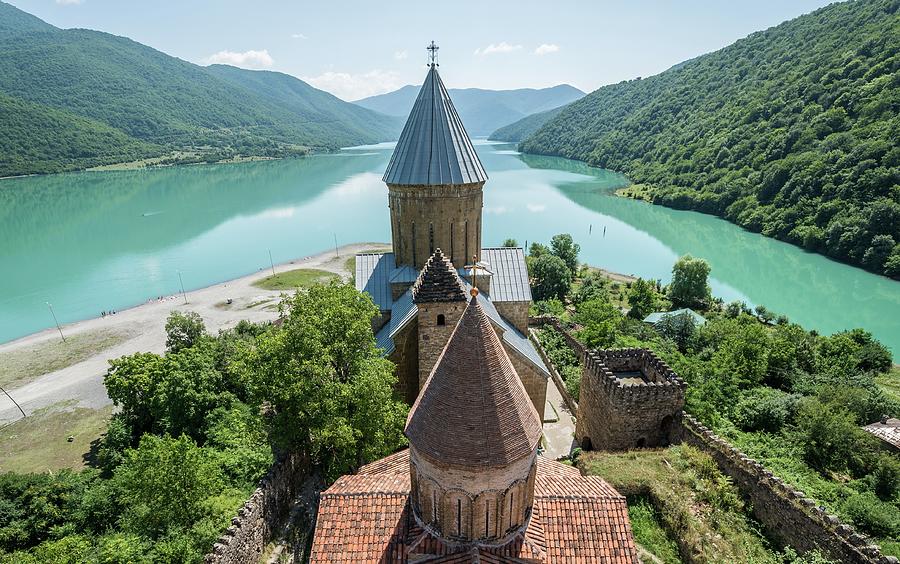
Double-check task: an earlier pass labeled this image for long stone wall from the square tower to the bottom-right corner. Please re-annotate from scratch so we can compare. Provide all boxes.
[678,415,898,564]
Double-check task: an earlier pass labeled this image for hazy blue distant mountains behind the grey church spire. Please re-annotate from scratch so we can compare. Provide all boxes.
[354,84,584,136]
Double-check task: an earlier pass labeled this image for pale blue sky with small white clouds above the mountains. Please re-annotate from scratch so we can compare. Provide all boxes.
[10,0,829,100]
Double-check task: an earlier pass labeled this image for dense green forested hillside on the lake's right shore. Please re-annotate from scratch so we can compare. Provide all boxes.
[521,0,900,279]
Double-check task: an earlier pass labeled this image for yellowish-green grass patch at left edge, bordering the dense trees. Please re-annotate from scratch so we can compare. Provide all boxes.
[0,402,113,473]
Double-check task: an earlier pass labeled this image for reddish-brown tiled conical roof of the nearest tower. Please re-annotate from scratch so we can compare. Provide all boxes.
[406,297,541,467]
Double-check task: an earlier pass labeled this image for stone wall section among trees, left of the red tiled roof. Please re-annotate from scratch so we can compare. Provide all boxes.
[204,454,309,564]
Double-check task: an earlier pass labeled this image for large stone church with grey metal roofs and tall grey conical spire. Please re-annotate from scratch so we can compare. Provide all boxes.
[355,51,550,414]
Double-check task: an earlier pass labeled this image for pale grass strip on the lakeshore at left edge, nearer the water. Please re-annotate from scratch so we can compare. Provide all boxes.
[0,329,131,388]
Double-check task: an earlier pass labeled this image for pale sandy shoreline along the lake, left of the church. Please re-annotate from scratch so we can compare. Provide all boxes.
[0,243,389,425]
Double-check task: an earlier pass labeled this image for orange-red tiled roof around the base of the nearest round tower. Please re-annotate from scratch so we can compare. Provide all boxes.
[310,451,638,564]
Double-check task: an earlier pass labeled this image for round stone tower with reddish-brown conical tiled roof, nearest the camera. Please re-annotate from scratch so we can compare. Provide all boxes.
[406,297,541,545]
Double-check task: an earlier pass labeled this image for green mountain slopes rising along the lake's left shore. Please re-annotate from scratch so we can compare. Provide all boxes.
[0,2,402,174]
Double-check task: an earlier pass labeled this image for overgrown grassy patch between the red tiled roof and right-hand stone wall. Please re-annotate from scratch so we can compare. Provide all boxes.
[578,445,780,562]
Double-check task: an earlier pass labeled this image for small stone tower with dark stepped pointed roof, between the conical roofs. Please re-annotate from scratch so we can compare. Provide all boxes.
[412,249,466,392]
